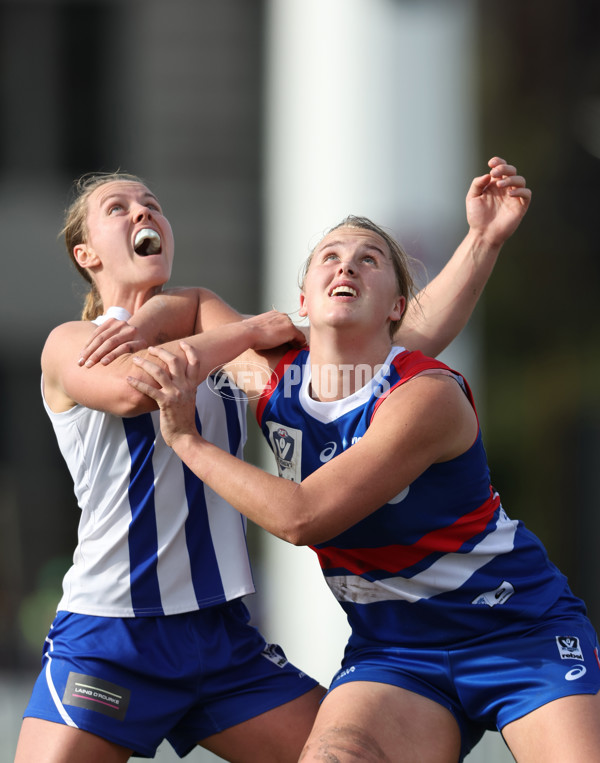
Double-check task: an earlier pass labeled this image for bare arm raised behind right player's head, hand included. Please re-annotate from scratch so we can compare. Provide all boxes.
[394,156,531,357]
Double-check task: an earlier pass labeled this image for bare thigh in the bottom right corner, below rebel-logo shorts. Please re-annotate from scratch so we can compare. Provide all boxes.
[502,694,600,763]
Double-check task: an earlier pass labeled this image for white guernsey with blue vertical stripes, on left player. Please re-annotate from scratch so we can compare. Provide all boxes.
[42,310,254,617]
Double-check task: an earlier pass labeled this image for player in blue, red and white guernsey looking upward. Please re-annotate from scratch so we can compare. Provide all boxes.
[130,170,600,763]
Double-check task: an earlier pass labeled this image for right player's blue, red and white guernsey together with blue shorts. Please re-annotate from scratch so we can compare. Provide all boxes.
[256,347,600,760]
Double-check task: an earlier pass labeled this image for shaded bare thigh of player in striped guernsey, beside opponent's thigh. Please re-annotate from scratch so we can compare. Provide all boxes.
[201,686,325,763]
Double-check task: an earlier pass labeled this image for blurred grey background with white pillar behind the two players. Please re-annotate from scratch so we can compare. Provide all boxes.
[0,0,600,763]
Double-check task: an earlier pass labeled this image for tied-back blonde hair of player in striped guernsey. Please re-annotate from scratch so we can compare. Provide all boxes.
[59,172,146,321]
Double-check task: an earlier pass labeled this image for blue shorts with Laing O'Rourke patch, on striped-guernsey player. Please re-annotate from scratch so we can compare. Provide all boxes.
[24,599,317,757]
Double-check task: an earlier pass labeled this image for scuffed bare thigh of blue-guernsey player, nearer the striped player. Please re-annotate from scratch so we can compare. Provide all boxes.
[300,681,461,763]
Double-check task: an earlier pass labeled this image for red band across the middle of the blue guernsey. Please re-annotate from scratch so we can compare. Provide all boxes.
[313,488,500,575]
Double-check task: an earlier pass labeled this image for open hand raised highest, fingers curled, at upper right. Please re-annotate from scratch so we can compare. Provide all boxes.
[466,156,531,246]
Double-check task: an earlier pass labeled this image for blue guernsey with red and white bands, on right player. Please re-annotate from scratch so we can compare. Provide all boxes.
[257,347,581,648]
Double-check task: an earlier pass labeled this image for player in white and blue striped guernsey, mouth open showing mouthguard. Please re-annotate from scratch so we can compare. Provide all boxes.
[15,175,322,763]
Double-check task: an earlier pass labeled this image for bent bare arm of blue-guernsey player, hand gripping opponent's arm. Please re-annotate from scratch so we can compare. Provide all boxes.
[129,348,477,545]
